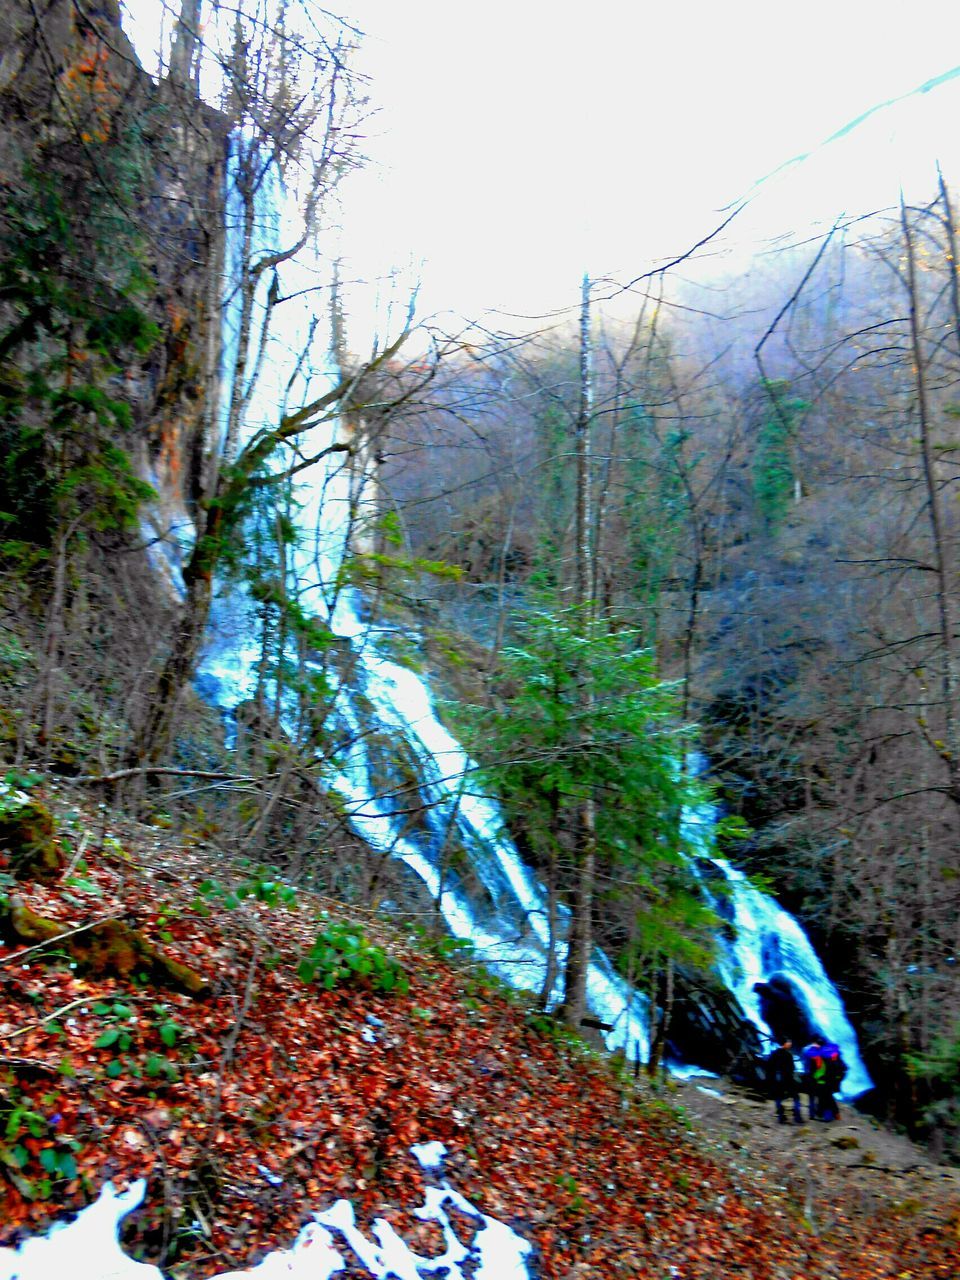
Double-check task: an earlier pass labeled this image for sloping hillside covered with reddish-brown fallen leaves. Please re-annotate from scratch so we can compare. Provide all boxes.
[0,787,960,1280]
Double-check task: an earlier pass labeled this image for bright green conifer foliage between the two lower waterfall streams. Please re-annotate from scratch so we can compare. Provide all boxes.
[466,608,716,969]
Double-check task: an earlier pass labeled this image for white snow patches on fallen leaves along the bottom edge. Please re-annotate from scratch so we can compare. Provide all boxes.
[0,1142,531,1280]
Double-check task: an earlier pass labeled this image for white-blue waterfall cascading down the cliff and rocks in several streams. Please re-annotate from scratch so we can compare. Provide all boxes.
[198,140,870,1094]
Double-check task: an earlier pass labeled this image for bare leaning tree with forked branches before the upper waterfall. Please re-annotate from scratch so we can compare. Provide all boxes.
[128,5,417,764]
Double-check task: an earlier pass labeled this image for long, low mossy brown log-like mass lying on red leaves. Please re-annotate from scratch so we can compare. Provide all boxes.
[0,893,210,997]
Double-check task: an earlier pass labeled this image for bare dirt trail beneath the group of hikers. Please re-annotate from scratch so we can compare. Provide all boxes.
[677,1079,960,1231]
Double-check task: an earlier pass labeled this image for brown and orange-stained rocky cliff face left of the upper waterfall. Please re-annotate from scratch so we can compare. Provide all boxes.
[0,0,227,565]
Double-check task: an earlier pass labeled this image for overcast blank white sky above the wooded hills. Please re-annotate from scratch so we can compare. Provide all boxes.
[128,0,960,335]
